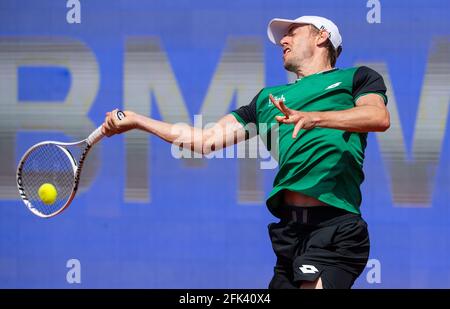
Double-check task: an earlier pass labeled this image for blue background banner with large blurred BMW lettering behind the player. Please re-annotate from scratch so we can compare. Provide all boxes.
[0,0,450,288]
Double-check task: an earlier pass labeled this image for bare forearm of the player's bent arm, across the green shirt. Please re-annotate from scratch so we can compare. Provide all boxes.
[312,105,389,132]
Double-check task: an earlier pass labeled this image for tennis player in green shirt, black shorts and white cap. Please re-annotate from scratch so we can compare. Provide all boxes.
[103,16,390,288]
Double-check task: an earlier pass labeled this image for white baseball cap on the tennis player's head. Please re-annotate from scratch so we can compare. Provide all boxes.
[267,16,342,49]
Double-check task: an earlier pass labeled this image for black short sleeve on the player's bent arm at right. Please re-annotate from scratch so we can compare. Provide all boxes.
[352,66,388,104]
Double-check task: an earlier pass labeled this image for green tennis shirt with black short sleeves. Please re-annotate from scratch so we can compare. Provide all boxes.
[231,67,387,216]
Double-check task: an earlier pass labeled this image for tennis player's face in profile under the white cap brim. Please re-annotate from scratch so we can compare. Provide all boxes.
[280,24,316,73]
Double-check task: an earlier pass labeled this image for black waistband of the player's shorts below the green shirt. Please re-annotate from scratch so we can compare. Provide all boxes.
[281,205,359,225]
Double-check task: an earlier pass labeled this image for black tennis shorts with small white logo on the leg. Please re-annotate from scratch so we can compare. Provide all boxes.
[269,206,370,289]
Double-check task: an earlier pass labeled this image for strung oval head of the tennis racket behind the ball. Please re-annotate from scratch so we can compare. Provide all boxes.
[22,144,74,215]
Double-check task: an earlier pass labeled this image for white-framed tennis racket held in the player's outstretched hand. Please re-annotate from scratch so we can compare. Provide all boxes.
[17,111,125,218]
